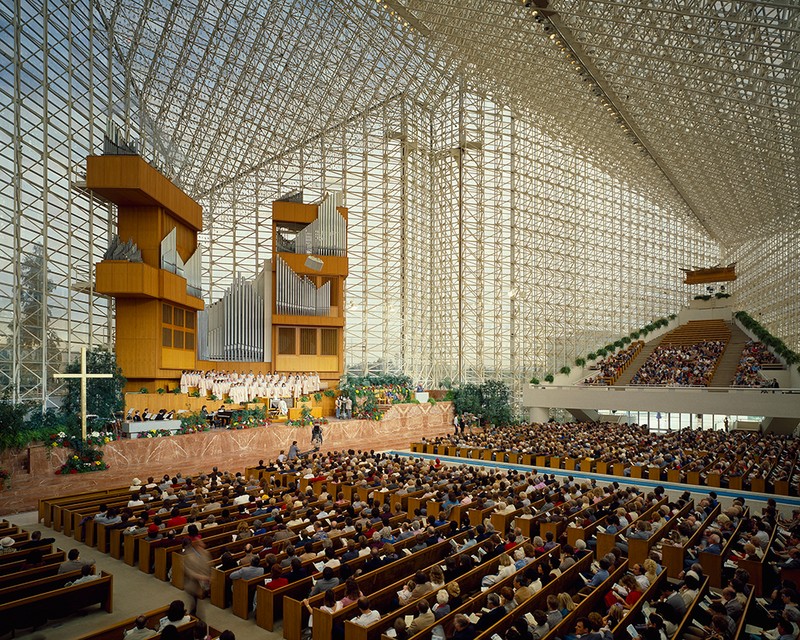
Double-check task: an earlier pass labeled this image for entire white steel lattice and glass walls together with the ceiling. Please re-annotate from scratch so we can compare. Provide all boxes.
[0,0,800,405]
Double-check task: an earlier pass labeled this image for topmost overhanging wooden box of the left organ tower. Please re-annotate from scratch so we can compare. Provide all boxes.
[86,156,203,231]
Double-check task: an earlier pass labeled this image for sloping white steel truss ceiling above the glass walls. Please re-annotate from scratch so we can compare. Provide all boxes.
[100,0,800,245]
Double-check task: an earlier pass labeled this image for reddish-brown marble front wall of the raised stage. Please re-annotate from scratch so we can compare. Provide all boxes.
[0,402,453,515]
